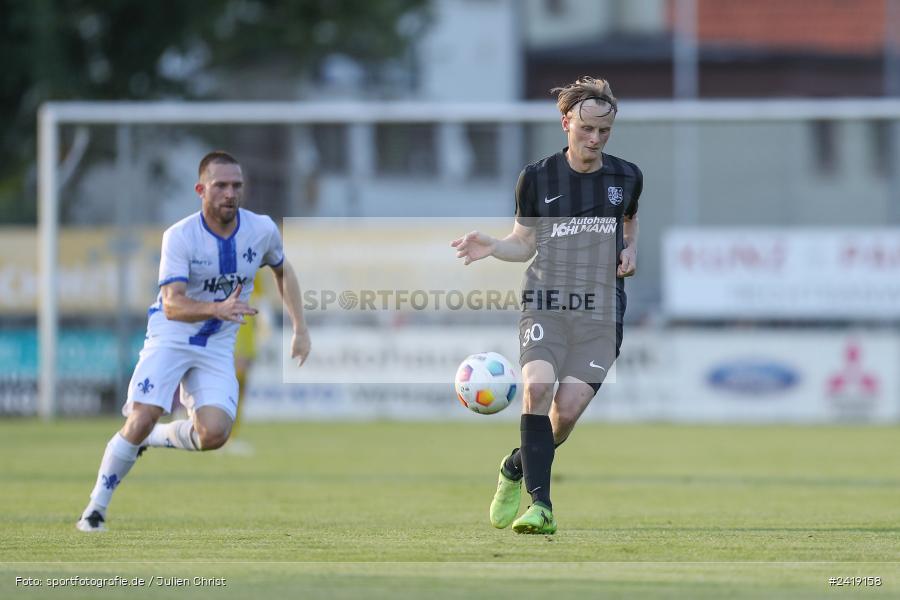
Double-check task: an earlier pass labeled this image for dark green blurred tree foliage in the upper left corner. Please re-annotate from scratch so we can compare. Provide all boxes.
[0,0,426,221]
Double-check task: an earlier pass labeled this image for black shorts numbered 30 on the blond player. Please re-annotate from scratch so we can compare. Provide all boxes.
[519,310,622,393]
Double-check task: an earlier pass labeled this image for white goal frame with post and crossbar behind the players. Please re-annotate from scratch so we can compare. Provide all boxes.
[37,98,900,419]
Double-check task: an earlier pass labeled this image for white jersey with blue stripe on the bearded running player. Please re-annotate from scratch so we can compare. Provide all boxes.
[144,209,284,353]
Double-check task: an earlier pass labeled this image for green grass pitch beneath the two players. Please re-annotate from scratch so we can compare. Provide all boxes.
[0,419,900,600]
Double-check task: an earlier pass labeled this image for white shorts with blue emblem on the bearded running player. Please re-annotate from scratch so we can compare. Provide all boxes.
[122,346,238,421]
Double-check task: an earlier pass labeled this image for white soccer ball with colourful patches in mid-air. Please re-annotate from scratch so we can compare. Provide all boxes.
[454,352,520,415]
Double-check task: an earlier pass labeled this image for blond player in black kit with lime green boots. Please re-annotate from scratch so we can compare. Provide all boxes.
[451,77,643,534]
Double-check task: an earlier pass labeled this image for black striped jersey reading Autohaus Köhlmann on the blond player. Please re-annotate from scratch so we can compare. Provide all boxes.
[516,148,643,319]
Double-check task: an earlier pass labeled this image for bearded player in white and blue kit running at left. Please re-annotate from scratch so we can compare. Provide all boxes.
[77,151,310,532]
